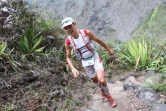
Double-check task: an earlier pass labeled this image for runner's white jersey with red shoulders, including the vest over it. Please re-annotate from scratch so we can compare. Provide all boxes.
[65,30,95,59]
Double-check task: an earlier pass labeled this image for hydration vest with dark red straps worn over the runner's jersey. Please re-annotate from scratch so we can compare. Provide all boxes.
[68,30,95,59]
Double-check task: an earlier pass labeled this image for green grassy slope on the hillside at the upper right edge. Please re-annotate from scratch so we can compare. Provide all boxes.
[134,6,166,43]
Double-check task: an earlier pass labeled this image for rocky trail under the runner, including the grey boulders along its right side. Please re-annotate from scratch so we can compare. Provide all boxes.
[78,72,166,111]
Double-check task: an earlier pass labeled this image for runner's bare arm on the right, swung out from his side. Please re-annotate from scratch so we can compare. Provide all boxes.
[87,30,114,56]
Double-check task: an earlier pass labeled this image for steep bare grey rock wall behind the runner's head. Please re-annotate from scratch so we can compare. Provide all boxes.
[26,0,166,41]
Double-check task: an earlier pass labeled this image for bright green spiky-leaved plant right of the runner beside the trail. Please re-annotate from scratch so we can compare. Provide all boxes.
[118,39,152,69]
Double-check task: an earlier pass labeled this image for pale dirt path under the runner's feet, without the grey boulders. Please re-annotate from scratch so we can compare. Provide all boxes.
[79,82,150,111]
